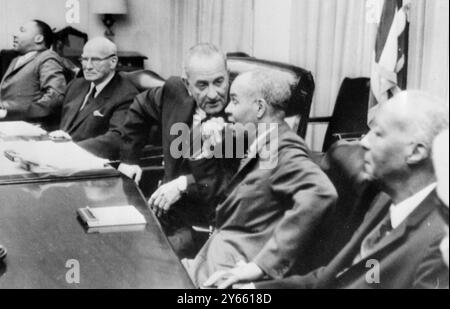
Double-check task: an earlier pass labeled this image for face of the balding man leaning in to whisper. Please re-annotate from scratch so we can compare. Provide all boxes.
[187,55,229,115]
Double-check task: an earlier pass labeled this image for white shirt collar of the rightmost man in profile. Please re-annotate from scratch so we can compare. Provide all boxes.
[389,183,436,229]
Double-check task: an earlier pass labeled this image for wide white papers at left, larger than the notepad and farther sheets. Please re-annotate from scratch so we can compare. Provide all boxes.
[0,141,108,172]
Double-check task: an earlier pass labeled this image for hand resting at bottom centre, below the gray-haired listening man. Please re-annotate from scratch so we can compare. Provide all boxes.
[204,263,264,289]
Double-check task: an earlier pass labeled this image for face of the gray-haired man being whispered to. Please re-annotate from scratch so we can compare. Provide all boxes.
[225,75,258,125]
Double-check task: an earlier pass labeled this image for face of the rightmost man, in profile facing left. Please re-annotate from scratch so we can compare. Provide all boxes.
[361,106,412,183]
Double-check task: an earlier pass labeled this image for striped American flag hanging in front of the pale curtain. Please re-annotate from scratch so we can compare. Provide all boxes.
[369,0,411,116]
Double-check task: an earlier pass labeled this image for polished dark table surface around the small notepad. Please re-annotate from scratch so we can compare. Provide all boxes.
[0,177,194,288]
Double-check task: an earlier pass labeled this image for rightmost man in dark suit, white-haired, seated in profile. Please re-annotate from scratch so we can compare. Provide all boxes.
[244,91,449,289]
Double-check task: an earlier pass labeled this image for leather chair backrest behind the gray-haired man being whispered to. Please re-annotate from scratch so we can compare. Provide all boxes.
[227,57,315,137]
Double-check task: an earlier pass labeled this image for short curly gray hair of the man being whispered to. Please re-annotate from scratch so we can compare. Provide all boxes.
[244,69,295,112]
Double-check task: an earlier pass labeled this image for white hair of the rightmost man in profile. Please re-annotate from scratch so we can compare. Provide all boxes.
[391,90,449,154]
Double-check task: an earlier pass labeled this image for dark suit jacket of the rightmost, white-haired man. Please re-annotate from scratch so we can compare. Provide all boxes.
[256,192,449,289]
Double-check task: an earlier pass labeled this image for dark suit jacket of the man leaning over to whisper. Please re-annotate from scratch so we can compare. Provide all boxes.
[121,77,232,204]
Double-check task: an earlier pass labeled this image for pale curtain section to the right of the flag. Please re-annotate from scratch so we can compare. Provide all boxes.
[408,0,449,102]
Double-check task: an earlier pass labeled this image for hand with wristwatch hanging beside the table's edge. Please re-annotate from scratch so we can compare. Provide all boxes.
[148,176,187,218]
